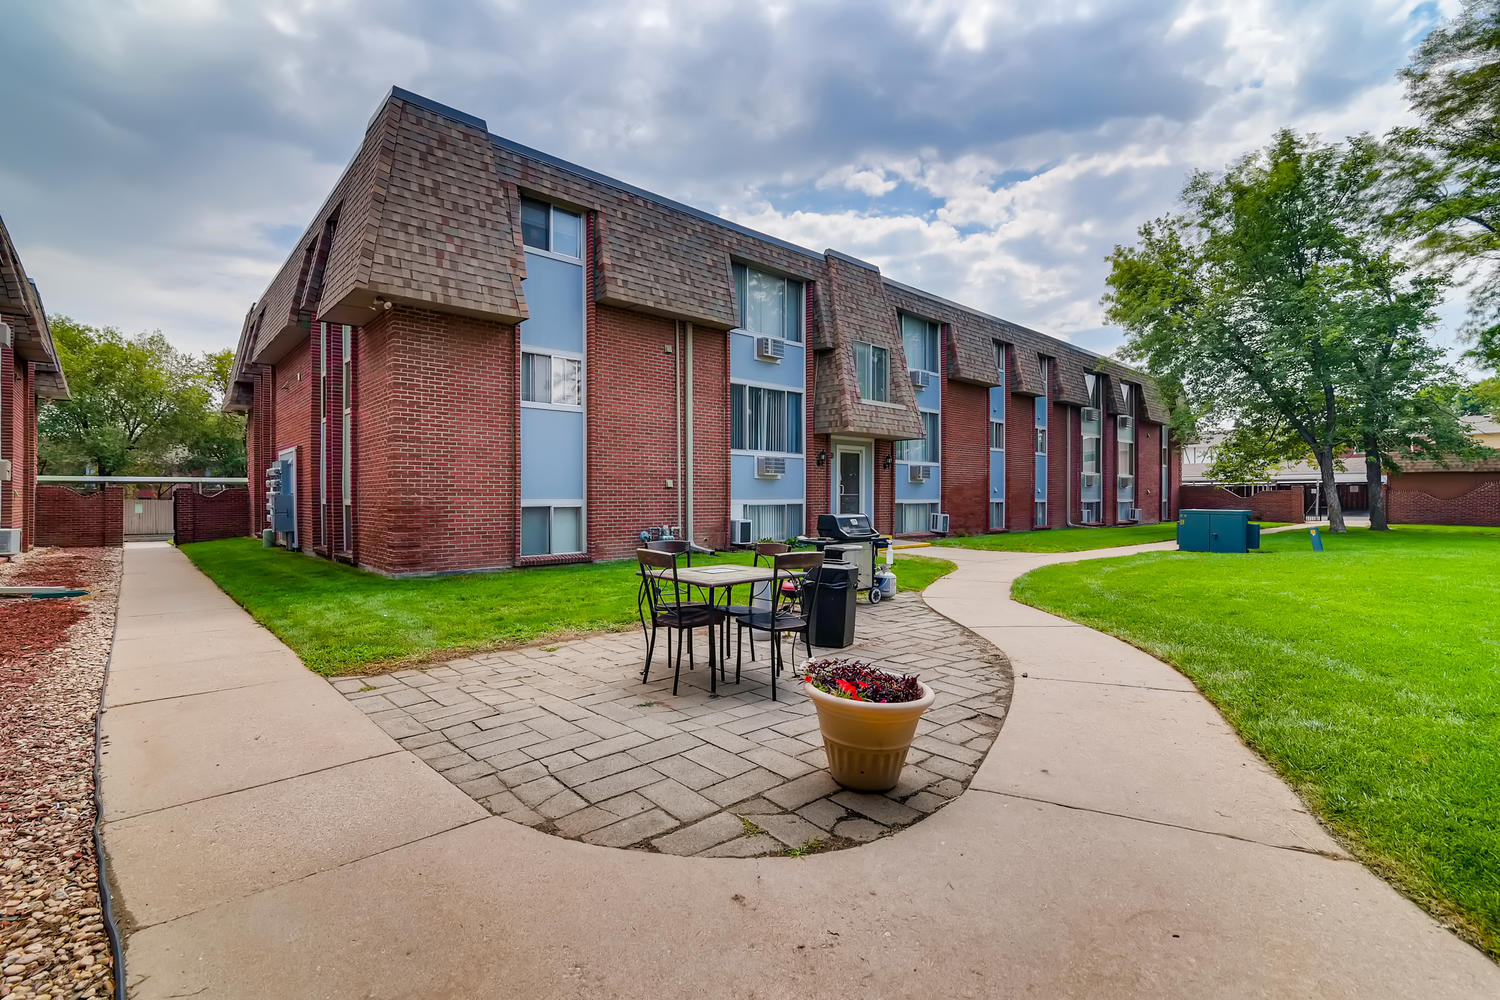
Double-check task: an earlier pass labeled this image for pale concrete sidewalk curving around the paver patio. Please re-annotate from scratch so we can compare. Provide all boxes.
[102,547,1500,999]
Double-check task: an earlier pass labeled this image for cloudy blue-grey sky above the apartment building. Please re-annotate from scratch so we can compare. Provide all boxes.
[0,0,1463,359]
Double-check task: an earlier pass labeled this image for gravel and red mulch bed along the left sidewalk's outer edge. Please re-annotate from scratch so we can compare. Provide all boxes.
[0,549,122,1000]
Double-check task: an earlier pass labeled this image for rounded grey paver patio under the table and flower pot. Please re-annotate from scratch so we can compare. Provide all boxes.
[333,593,1011,858]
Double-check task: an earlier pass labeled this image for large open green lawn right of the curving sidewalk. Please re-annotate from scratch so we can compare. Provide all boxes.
[1014,526,1500,955]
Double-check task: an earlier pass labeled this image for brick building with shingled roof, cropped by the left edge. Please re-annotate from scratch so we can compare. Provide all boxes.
[0,219,68,556]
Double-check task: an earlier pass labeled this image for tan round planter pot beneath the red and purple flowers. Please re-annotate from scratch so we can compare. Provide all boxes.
[803,681,938,792]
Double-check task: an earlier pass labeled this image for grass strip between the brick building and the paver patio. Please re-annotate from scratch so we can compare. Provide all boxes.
[182,538,954,676]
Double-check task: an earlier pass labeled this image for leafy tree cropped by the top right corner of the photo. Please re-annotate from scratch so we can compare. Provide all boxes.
[1389,0,1500,366]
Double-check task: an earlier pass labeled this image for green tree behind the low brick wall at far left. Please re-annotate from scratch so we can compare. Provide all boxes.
[38,316,245,475]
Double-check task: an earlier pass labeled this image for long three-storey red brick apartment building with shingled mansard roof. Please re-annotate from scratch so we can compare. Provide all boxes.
[227,90,1178,574]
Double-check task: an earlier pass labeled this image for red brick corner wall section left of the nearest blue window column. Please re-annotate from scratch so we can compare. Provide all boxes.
[354,306,519,573]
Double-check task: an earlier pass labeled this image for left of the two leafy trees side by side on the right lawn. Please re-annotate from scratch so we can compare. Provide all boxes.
[1104,130,1365,532]
